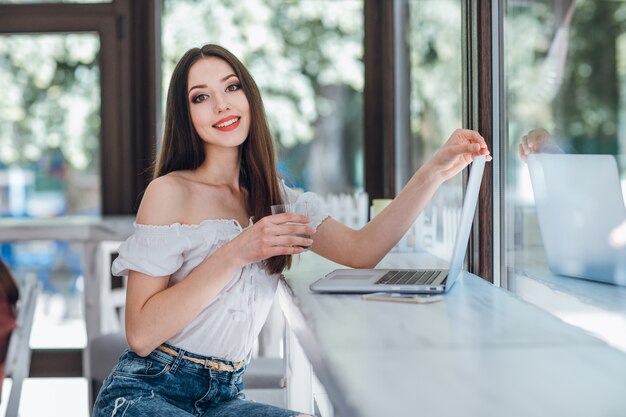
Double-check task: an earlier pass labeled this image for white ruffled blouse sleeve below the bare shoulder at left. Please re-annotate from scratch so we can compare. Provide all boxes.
[111,224,190,277]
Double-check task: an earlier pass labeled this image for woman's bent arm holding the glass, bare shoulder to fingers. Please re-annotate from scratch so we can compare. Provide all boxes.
[126,177,315,356]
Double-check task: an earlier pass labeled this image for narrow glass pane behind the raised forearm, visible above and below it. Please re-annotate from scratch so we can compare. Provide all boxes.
[402,0,463,259]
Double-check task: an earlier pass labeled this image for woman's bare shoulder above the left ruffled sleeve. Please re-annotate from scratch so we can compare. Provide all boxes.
[137,175,189,225]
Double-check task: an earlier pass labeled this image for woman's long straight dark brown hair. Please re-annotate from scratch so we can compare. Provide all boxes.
[154,44,291,274]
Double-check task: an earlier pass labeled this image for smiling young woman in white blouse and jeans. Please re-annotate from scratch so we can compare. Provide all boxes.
[94,45,489,417]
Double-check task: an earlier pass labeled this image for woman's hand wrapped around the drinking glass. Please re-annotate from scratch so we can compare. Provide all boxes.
[227,213,315,265]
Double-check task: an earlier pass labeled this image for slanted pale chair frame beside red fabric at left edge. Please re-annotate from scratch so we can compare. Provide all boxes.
[5,280,39,417]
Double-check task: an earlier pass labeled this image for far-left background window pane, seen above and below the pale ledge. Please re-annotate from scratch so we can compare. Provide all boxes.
[0,34,101,347]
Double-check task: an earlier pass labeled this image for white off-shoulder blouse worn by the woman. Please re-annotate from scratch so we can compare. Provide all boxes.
[112,185,328,361]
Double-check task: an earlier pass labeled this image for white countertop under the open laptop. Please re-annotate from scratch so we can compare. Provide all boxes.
[279,253,626,417]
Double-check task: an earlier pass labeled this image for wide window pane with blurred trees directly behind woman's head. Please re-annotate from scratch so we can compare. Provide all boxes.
[162,0,363,194]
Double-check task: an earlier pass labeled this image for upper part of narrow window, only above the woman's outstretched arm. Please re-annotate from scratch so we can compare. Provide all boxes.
[408,0,463,171]
